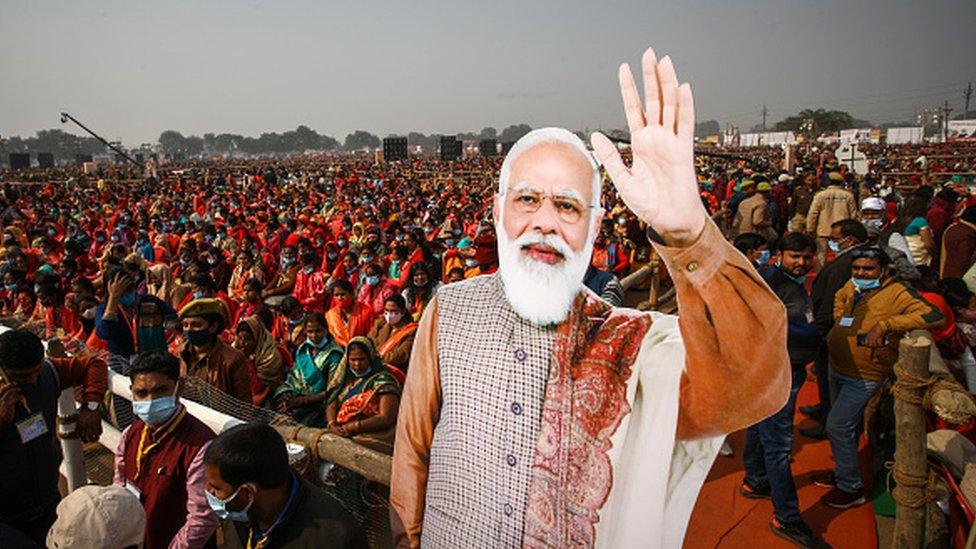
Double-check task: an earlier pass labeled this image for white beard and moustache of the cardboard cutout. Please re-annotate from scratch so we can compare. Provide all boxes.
[495,220,594,326]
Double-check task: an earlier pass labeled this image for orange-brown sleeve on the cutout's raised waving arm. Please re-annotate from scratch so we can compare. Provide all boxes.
[654,217,791,439]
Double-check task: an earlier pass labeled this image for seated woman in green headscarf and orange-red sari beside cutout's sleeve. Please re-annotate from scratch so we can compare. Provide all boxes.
[325,337,400,454]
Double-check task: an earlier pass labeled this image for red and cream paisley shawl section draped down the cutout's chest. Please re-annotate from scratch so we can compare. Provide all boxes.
[523,291,651,547]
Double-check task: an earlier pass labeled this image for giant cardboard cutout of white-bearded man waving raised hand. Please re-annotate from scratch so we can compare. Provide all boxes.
[390,49,790,547]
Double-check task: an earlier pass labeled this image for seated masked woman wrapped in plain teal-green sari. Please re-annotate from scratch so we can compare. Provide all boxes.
[274,313,343,427]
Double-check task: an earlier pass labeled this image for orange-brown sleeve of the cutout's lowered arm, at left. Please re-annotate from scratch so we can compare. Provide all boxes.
[390,297,441,547]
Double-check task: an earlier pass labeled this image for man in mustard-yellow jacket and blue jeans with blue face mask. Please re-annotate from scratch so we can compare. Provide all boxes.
[814,246,945,509]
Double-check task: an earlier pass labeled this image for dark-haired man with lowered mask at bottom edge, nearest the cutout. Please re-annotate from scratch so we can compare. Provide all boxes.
[204,423,368,549]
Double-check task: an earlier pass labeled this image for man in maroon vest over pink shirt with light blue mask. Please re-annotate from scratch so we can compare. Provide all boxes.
[114,351,218,549]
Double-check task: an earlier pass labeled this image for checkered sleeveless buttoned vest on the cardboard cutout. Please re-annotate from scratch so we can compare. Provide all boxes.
[421,275,555,548]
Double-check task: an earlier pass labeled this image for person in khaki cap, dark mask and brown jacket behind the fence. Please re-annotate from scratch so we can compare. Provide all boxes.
[179,298,251,402]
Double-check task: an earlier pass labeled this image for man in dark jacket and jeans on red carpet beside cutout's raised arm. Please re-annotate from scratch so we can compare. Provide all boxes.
[739,233,826,547]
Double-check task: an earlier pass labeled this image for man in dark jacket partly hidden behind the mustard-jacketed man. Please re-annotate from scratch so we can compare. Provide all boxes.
[799,219,868,440]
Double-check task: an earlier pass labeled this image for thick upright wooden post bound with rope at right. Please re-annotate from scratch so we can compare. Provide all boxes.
[892,337,931,549]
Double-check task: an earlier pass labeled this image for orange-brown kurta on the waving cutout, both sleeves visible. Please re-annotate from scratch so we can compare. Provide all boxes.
[390,222,790,547]
